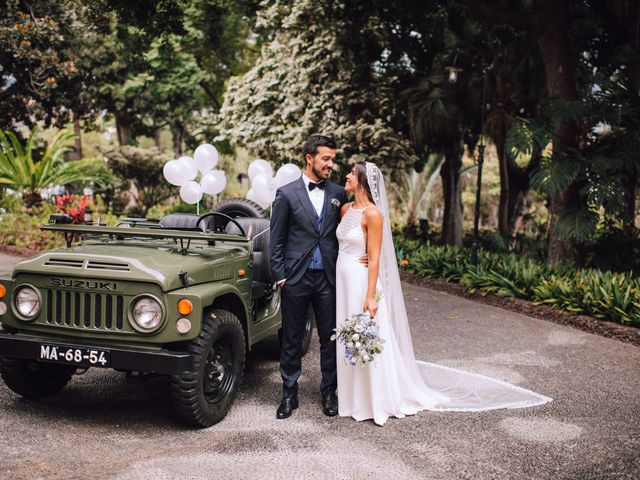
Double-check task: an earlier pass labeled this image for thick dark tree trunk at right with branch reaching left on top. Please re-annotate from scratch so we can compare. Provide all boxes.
[462,0,593,263]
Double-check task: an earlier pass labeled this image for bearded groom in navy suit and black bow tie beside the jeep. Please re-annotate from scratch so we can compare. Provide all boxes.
[271,135,347,419]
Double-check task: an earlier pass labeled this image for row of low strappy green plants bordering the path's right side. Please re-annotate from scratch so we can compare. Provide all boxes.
[397,238,640,326]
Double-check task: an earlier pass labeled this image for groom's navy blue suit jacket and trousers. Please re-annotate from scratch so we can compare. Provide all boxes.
[270,178,347,397]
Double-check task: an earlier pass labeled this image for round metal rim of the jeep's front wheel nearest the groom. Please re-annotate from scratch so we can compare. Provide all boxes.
[203,336,235,403]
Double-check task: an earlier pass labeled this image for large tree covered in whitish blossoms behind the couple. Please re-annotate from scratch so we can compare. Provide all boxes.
[219,0,416,170]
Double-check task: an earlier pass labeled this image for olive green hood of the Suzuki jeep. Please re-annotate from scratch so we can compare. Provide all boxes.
[13,242,247,291]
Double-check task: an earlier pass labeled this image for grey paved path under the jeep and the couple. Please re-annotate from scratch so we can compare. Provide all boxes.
[0,255,640,480]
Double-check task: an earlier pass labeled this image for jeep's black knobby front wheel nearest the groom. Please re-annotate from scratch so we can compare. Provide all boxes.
[171,310,245,428]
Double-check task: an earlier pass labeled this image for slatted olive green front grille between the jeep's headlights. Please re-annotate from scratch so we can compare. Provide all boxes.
[46,290,129,332]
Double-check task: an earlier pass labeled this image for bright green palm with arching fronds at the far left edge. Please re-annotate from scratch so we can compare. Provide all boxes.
[0,130,111,207]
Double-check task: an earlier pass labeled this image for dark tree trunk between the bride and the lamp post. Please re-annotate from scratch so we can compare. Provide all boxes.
[440,138,463,246]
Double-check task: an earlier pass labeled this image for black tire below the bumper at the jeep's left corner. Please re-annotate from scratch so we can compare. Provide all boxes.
[0,358,76,399]
